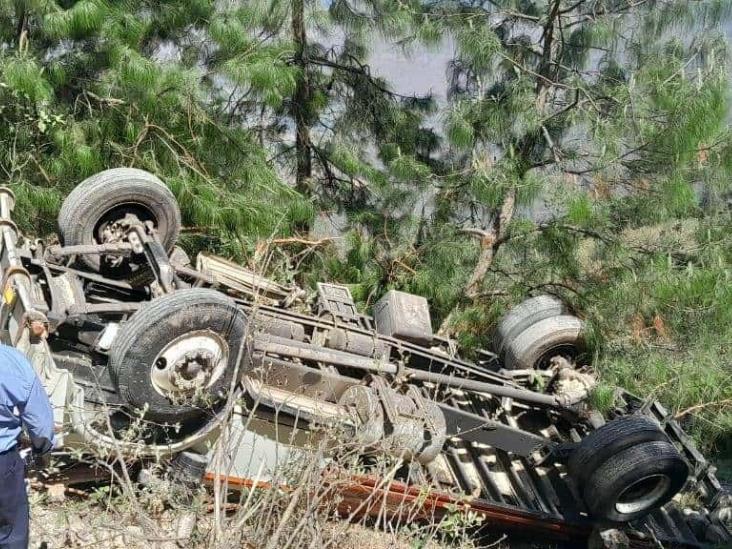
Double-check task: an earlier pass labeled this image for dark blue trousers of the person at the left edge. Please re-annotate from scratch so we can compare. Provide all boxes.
[0,449,28,549]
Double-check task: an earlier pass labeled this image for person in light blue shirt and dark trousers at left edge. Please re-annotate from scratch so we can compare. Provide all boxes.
[0,345,54,549]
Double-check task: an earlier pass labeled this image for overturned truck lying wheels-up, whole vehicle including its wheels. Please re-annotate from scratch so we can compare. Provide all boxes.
[0,168,730,546]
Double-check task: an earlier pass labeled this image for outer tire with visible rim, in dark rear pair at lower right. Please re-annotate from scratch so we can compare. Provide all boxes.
[582,441,689,523]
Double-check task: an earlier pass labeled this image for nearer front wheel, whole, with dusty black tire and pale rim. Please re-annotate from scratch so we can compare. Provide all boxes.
[109,289,247,424]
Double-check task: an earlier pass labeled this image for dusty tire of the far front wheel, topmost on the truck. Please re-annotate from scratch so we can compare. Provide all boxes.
[58,168,181,271]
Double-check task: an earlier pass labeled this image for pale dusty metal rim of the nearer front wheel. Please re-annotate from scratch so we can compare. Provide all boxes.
[150,330,229,397]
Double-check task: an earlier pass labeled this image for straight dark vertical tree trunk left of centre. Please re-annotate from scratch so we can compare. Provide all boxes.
[292,0,313,195]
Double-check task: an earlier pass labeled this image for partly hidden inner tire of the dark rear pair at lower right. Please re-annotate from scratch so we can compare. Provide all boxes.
[567,416,668,486]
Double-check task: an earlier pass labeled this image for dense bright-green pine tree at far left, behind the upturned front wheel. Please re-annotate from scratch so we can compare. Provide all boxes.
[0,0,312,251]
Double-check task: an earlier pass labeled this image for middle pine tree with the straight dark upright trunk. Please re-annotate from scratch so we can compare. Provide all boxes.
[213,0,437,230]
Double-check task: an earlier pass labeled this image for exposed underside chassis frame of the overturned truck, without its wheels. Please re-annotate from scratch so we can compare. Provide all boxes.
[0,174,732,546]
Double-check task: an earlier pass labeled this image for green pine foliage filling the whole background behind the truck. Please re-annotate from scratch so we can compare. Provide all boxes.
[0,0,732,460]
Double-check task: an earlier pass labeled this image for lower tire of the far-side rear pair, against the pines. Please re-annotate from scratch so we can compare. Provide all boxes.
[504,315,585,370]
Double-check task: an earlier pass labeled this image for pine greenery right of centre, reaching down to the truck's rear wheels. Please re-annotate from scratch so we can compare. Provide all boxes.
[399,0,732,450]
